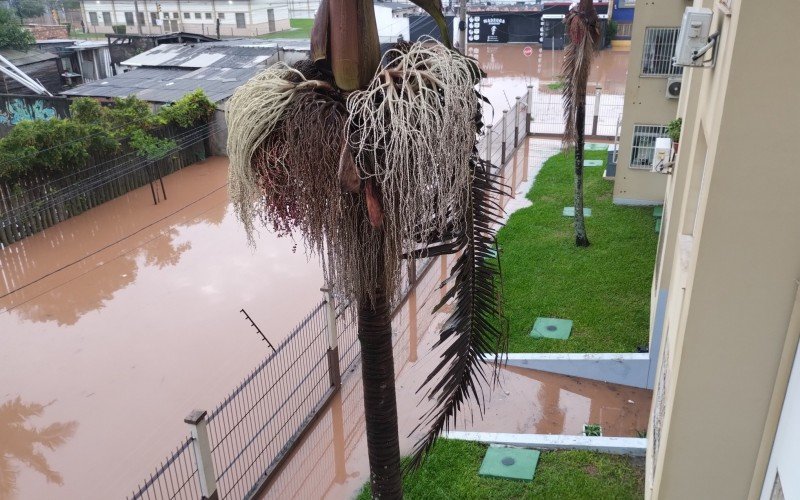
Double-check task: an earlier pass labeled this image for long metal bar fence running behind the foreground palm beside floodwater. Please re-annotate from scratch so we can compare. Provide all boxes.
[129,89,530,499]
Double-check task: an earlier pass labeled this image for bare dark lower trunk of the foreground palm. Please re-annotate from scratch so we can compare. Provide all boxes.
[358,262,403,499]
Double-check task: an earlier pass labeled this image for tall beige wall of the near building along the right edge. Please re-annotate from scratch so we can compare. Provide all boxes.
[648,0,800,499]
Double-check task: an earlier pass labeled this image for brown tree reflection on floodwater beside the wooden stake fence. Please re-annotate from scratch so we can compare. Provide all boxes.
[0,188,227,326]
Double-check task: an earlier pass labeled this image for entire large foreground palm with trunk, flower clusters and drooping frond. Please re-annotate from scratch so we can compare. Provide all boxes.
[226,0,506,499]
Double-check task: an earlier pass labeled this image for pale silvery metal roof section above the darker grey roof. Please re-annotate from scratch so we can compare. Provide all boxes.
[122,39,278,69]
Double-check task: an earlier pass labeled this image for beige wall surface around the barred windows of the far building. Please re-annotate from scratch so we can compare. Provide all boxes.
[614,0,688,205]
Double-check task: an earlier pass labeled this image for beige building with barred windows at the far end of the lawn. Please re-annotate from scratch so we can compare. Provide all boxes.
[614,0,688,205]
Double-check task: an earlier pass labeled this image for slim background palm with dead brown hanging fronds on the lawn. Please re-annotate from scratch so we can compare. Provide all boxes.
[562,0,600,247]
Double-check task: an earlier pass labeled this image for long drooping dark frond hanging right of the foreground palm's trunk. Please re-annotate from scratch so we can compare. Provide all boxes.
[409,155,508,469]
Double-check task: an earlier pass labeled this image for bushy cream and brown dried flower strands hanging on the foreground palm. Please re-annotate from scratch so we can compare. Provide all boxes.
[227,43,479,299]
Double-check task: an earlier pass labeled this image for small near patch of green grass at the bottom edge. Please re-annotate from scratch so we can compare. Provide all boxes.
[358,439,644,500]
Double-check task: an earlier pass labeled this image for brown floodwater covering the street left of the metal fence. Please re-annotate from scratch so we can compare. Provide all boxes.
[0,158,322,499]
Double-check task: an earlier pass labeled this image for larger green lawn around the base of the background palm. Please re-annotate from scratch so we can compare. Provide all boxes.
[497,152,658,352]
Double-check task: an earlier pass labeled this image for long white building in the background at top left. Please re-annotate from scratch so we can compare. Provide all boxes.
[81,0,289,37]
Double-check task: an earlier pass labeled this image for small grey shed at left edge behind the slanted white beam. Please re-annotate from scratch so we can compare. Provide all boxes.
[0,49,63,95]
